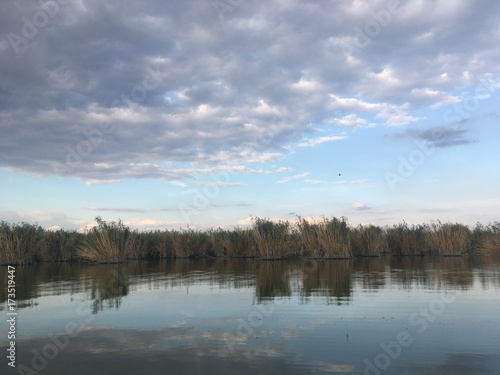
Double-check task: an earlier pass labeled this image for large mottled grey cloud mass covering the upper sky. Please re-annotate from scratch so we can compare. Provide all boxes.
[0,0,500,181]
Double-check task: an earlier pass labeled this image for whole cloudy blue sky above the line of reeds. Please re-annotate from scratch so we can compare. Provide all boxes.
[0,0,500,230]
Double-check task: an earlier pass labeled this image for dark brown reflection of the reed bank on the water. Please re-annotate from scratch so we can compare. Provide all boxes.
[0,257,500,313]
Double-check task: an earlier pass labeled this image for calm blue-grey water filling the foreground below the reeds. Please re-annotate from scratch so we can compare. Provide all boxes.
[0,257,500,375]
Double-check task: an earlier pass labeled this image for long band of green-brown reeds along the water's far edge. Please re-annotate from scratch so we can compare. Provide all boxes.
[0,217,500,265]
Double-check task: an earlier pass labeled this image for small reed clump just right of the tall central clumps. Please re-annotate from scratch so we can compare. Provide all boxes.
[351,225,387,256]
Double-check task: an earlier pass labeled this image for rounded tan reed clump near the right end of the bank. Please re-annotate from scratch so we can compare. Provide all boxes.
[426,221,470,255]
